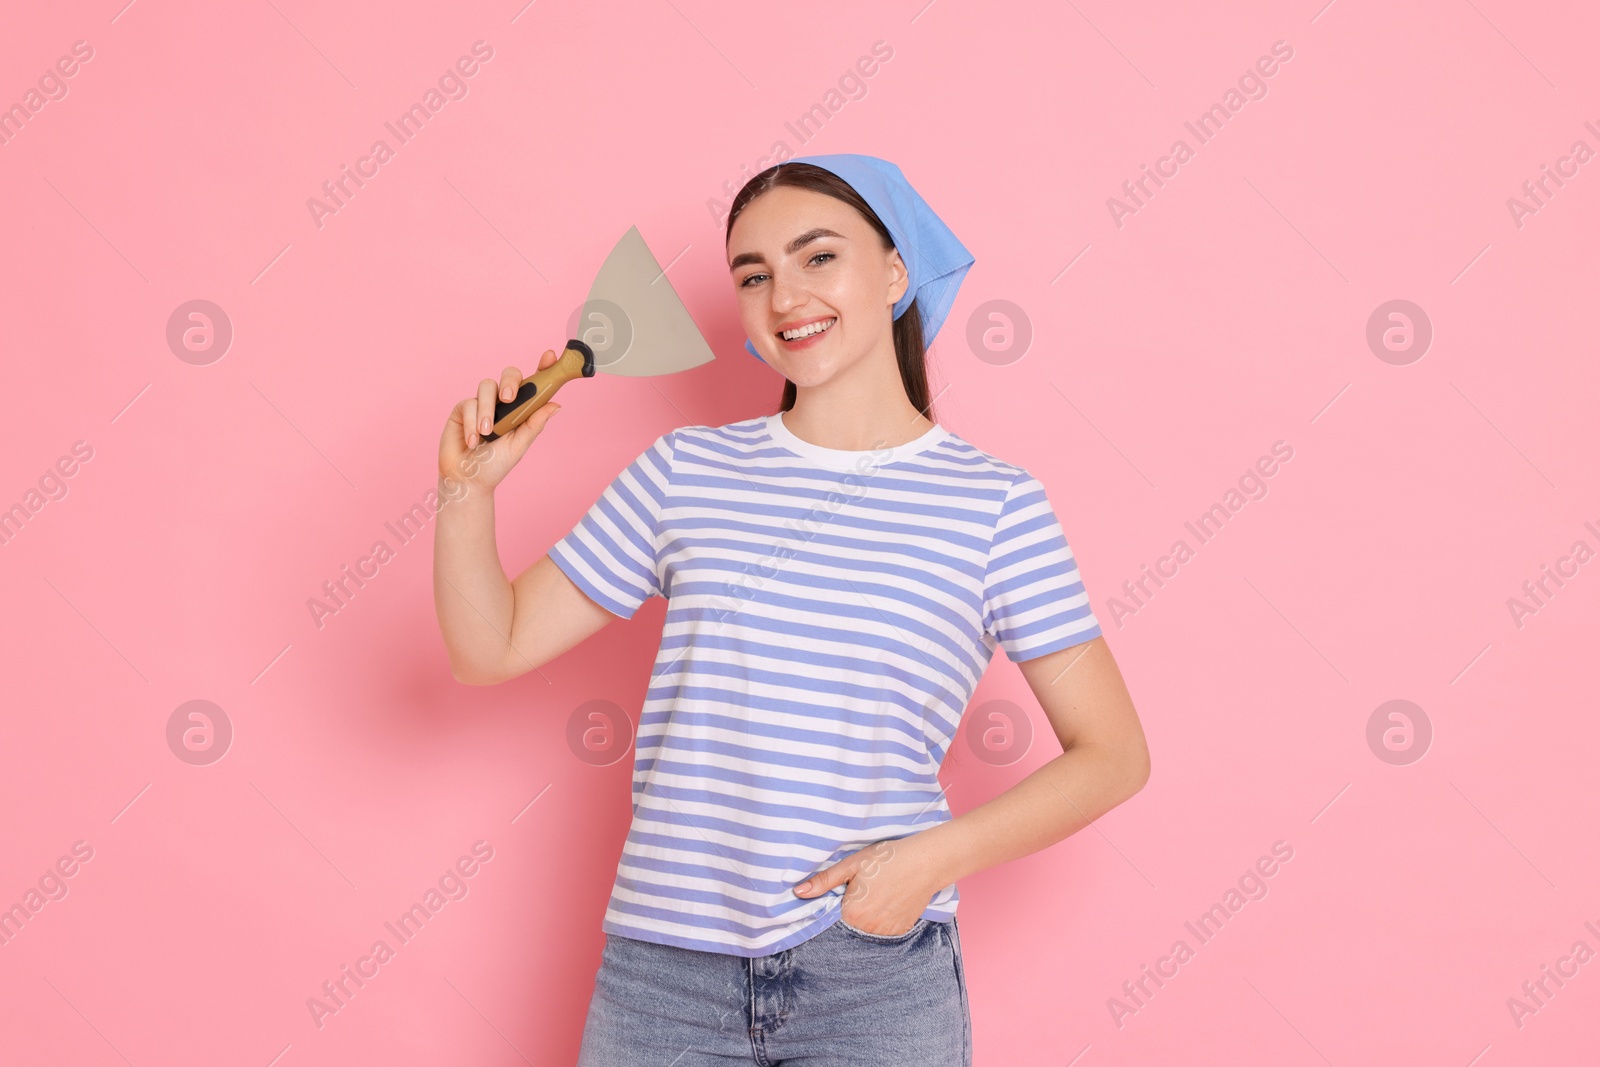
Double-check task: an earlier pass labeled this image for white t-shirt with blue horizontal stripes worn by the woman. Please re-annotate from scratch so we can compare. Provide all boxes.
[549,414,1101,957]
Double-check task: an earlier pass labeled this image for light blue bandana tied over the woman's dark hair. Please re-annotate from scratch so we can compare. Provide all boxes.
[744,154,973,363]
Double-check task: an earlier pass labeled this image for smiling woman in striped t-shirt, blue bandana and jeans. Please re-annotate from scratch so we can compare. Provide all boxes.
[435,155,1149,1067]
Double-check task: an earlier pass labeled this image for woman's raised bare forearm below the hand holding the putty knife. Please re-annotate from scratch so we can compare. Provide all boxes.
[434,478,515,685]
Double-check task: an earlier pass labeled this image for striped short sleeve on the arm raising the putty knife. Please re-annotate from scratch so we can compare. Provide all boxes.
[549,434,674,619]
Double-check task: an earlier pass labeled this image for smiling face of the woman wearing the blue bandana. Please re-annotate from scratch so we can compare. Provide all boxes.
[728,186,909,386]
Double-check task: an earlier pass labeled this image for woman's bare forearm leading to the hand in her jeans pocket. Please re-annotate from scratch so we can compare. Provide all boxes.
[894,742,1146,891]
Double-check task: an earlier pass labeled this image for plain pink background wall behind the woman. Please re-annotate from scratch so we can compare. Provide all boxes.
[0,0,1600,1067]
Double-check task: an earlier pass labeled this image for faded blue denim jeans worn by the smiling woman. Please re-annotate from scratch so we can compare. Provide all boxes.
[578,918,973,1067]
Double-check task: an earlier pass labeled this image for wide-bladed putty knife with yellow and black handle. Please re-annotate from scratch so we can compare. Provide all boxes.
[483,226,717,442]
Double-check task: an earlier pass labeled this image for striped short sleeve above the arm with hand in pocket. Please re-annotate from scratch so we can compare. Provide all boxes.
[984,470,1101,662]
